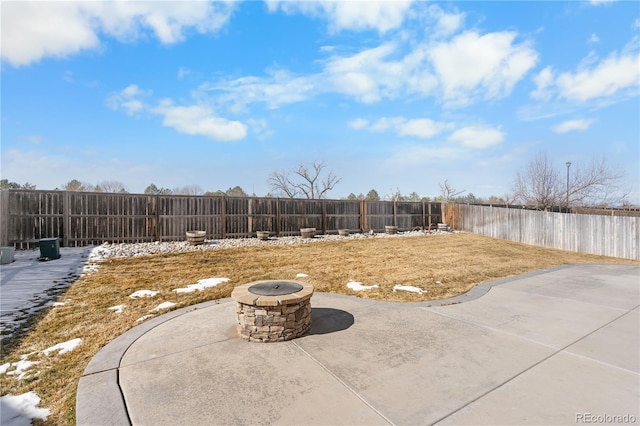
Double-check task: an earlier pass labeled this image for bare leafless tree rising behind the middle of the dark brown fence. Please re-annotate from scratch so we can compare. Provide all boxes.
[269,161,342,199]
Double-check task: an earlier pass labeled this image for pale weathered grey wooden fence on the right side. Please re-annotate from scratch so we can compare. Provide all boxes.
[443,204,640,260]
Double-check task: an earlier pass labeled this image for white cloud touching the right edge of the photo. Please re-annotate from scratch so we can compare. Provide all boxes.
[556,52,640,102]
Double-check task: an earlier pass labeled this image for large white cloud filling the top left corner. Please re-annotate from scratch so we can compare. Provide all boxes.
[1,1,234,66]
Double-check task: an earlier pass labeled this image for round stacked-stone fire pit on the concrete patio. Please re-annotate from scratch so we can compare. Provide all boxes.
[231,280,313,343]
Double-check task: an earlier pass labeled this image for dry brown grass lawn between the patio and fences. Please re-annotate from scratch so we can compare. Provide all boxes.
[0,234,640,424]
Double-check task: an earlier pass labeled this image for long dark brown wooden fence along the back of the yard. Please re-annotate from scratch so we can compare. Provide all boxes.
[0,190,442,248]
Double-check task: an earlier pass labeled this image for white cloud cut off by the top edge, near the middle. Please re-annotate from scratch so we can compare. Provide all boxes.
[267,0,412,33]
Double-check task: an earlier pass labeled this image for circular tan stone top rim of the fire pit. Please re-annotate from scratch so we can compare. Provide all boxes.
[231,280,313,306]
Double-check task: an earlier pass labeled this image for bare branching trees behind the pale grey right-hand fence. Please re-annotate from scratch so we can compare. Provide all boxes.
[513,153,626,210]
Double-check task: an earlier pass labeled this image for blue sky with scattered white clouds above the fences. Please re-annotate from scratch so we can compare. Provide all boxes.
[1,1,640,203]
